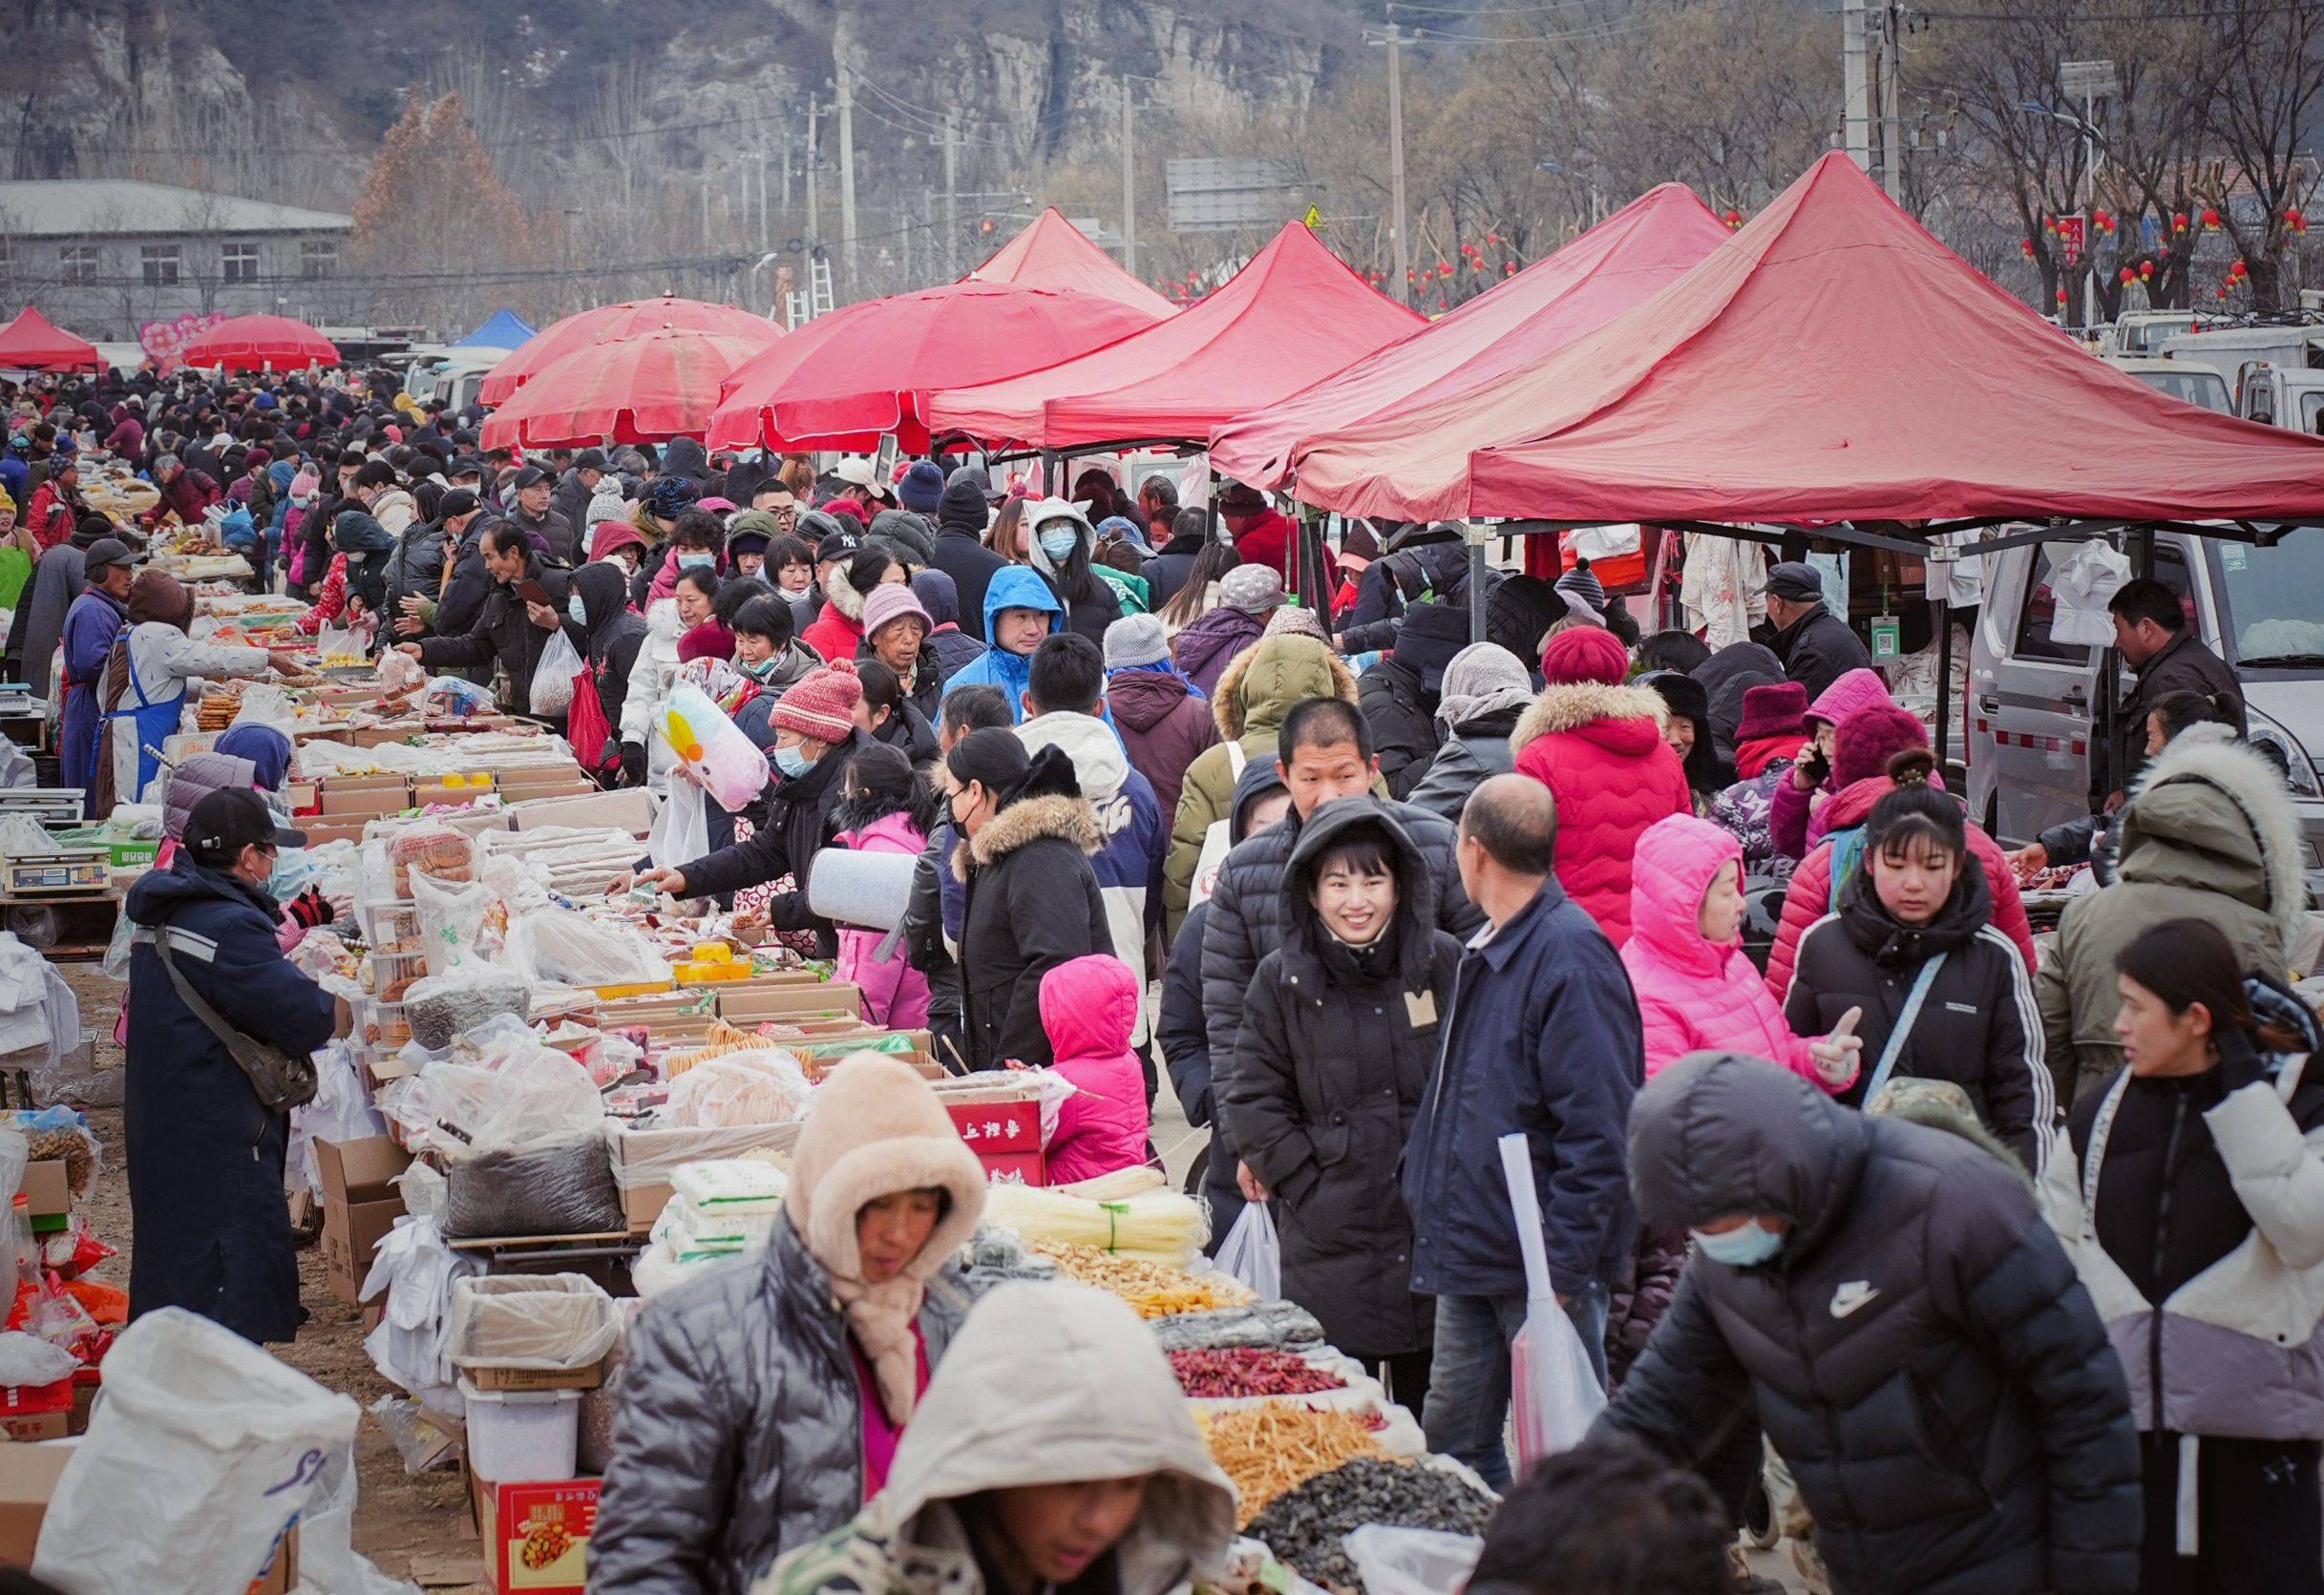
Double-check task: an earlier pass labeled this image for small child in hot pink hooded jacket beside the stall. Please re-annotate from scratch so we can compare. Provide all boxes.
[1041,952,1148,1184]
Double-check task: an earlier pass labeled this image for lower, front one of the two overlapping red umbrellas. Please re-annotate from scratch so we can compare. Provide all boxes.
[483,327,762,448]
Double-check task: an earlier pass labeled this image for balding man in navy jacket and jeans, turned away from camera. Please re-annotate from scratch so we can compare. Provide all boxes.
[1404,775,1645,1491]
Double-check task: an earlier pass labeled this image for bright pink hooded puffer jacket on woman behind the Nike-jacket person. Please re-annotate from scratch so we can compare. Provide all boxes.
[1622,815,1843,1091]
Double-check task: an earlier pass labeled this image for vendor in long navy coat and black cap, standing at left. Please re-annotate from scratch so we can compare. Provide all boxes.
[121,787,342,1344]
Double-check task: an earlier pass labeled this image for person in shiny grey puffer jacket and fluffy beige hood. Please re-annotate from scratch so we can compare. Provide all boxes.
[595,1052,985,1595]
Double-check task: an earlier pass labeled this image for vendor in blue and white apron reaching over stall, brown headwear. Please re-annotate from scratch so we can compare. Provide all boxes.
[88,571,300,815]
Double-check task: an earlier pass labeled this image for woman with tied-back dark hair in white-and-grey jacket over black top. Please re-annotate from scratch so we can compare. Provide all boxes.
[2042,919,2324,1595]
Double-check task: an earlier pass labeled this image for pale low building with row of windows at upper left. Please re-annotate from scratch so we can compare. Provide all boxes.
[0,178,355,342]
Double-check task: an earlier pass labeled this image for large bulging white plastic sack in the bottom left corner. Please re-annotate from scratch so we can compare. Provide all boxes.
[32,1307,358,1595]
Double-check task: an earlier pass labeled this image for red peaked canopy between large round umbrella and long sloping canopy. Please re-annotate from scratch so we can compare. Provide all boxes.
[930,223,1426,448]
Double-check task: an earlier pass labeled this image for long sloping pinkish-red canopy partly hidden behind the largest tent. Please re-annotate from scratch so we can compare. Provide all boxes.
[1211,183,1729,492]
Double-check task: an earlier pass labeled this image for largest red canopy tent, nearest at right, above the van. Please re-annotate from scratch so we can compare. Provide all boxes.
[1332,154,2324,524]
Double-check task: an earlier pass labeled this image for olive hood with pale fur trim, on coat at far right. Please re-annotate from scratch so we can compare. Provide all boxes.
[2115,726,2308,955]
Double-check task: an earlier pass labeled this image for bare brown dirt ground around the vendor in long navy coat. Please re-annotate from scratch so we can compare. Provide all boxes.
[63,963,491,1595]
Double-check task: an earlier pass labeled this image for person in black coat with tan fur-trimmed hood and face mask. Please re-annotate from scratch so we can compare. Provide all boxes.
[943,729,1113,1068]
